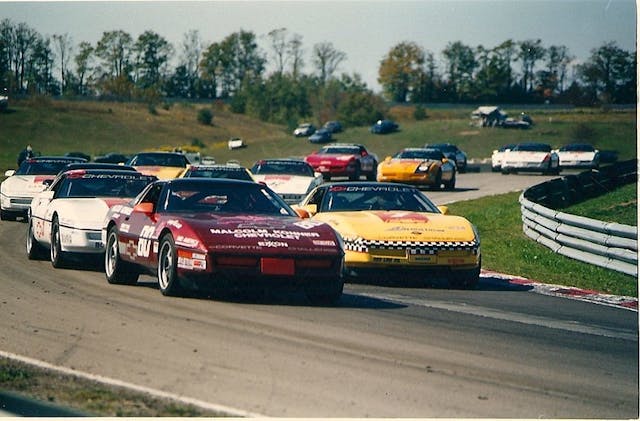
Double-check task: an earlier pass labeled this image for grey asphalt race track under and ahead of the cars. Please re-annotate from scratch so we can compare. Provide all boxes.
[0,173,638,418]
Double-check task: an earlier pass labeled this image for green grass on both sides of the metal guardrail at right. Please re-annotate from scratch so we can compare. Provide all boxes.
[448,184,638,297]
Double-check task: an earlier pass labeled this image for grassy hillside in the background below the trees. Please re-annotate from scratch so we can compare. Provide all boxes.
[0,98,637,169]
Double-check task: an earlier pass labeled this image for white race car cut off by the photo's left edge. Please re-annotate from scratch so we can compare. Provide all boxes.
[0,156,85,221]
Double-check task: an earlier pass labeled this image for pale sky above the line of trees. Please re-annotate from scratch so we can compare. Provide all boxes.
[0,0,637,91]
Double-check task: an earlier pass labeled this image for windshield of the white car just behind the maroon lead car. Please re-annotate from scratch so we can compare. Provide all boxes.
[56,174,155,198]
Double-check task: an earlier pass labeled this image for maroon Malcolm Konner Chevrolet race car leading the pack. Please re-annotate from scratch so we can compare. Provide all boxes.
[102,178,344,304]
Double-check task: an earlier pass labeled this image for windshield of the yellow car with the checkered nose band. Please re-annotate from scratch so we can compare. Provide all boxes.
[321,187,440,213]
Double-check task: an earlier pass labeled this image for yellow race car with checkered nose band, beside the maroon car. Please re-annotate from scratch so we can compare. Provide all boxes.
[298,182,481,288]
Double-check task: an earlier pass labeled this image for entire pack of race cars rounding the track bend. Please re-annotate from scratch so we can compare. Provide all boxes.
[0,144,597,304]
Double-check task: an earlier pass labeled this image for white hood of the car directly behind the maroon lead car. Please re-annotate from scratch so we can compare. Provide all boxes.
[54,197,131,230]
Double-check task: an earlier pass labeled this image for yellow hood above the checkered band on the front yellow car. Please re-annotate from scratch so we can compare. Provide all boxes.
[313,210,476,242]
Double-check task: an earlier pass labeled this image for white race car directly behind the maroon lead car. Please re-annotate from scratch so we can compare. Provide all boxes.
[26,169,157,267]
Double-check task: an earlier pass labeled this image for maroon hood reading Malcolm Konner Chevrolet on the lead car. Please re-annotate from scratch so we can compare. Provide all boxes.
[171,213,342,255]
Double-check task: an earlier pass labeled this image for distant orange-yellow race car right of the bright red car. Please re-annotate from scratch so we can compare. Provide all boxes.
[376,148,457,190]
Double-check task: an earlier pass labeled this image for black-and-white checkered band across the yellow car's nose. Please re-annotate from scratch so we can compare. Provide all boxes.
[344,238,478,255]
